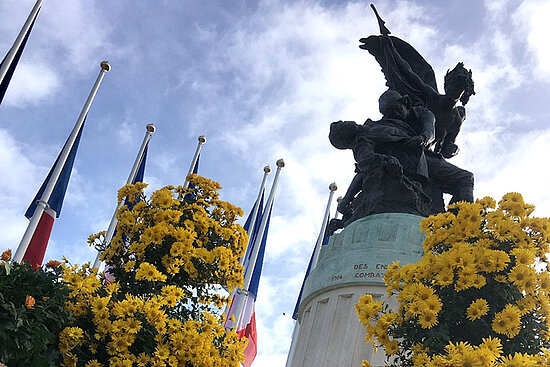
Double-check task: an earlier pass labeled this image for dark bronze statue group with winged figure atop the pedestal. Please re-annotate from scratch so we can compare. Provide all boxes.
[329,7,475,232]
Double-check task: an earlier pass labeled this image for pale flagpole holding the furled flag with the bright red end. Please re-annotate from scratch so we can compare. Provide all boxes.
[235,159,285,325]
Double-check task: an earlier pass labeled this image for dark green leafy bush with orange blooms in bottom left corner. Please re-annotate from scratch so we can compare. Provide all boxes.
[0,261,69,367]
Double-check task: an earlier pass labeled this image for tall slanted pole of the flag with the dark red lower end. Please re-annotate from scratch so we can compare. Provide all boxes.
[13,61,111,262]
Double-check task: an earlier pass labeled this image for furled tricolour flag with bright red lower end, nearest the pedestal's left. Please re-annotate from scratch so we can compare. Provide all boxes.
[226,193,271,367]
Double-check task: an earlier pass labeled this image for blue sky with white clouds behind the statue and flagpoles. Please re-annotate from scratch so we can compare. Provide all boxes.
[0,0,550,367]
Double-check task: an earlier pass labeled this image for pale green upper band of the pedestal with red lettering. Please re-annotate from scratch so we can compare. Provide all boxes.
[301,213,424,310]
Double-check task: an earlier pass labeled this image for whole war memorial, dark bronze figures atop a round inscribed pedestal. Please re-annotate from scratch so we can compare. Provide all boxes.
[287,6,475,367]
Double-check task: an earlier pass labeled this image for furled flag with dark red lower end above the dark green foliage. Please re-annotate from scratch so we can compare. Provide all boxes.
[23,118,86,267]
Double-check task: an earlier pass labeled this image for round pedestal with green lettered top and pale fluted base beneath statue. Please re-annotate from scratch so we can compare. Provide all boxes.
[287,213,424,367]
